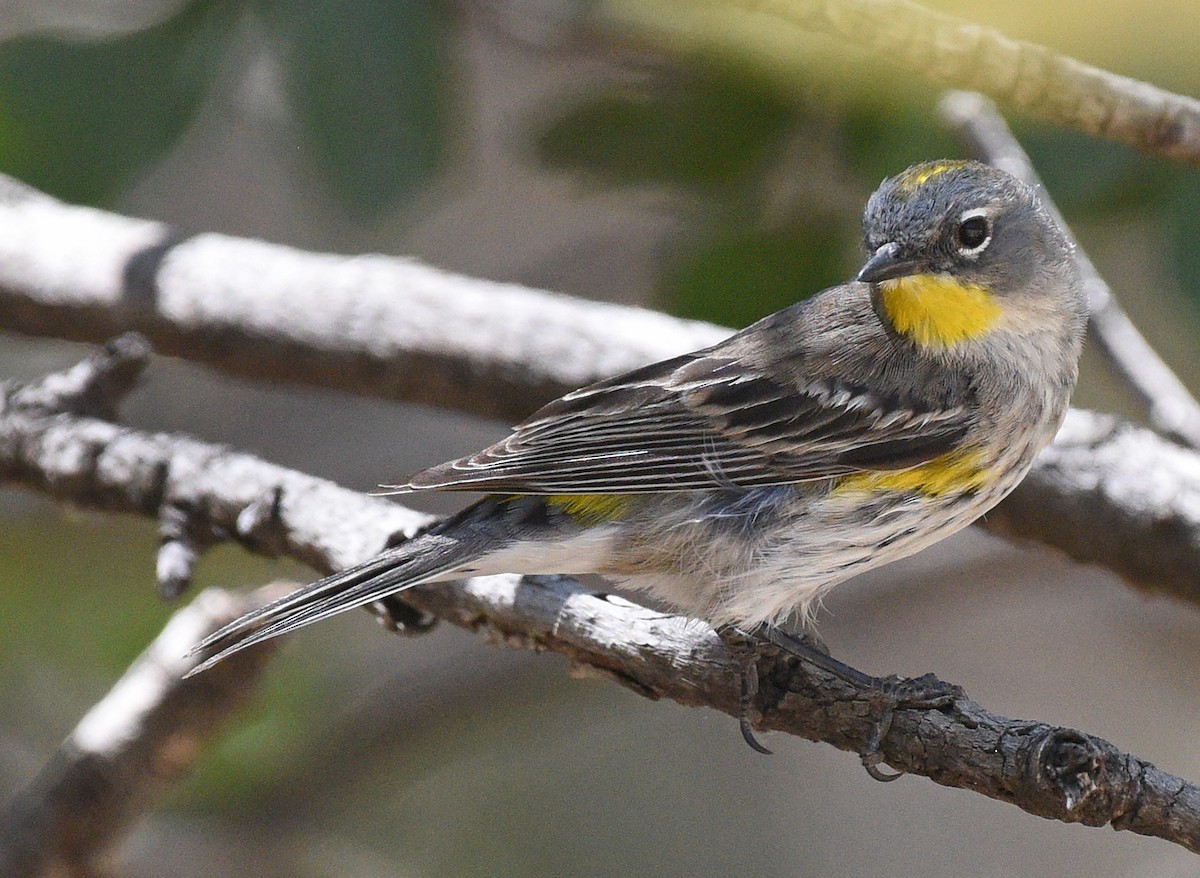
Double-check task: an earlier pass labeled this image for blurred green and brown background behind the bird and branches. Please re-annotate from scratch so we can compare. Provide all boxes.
[0,0,1200,878]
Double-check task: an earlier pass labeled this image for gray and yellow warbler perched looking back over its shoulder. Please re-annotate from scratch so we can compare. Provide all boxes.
[194,161,1085,661]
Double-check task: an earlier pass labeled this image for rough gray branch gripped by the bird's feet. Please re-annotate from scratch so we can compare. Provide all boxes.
[0,345,1200,850]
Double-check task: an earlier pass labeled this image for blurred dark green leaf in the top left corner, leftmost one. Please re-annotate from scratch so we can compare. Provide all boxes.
[0,0,239,204]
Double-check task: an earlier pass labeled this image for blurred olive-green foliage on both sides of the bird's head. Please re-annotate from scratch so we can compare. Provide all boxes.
[538,44,1200,326]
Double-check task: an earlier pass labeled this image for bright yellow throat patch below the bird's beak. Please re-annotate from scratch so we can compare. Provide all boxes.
[880,275,1002,348]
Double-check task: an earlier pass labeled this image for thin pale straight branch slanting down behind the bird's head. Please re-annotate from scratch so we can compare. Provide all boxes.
[941,91,1200,449]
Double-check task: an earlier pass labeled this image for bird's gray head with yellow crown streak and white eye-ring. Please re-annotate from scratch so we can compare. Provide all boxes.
[858,161,1078,302]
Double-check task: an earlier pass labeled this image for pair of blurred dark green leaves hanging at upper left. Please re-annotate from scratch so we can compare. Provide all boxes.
[0,0,446,216]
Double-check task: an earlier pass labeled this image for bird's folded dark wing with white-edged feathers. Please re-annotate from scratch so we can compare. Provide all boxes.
[400,354,967,494]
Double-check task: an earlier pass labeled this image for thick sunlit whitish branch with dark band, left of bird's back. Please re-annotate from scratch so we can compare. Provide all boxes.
[0,176,728,420]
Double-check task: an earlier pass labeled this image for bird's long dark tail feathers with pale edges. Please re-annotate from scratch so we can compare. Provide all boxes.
[187,534,481,676]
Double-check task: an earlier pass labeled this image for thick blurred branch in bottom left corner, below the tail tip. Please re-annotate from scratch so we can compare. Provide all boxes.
[0,587,282,878]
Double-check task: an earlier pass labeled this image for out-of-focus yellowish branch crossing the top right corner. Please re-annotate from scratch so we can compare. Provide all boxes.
[601,0,1200,168]
